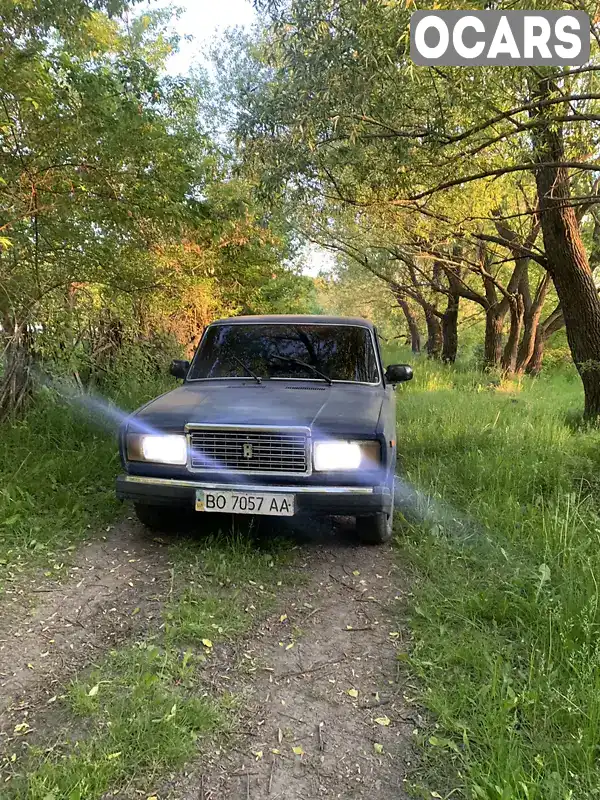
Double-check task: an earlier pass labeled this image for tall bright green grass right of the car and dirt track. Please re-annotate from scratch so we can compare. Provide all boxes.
[398,354,600,800]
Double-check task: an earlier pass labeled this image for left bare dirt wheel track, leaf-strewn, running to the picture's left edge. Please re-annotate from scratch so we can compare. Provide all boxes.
[0,521,171,750]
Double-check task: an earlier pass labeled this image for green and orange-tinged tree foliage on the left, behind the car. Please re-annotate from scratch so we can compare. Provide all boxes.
[0,0,314,415]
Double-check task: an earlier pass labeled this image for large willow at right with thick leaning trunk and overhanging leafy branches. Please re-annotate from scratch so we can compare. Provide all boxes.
[238,0,600,417]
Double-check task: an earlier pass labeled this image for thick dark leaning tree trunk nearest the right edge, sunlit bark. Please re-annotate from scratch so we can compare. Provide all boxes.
[532,79,600,419]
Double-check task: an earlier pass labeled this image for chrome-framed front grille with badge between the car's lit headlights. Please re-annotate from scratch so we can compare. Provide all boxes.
[190,428,309,473]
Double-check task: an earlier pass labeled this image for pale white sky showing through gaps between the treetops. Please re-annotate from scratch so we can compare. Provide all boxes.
[156,0,333,277]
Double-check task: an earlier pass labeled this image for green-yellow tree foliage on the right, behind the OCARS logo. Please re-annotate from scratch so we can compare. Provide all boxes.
[223,0,600,404]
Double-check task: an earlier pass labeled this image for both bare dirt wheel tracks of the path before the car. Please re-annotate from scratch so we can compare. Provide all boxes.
[0,522,422,800]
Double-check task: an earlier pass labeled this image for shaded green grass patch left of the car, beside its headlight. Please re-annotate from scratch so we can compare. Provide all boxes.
[0,376,172,590]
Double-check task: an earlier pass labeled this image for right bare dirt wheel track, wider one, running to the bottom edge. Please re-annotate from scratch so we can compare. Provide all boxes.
[169,530,425,800]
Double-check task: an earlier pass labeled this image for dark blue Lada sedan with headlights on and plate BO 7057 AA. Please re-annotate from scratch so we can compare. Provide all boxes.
[117,316,412,544]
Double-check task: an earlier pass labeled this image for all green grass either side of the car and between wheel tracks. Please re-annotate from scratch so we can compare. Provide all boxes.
[0,355,600,800]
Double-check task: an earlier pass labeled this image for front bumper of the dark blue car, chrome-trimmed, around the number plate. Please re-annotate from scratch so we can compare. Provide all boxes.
[117,475,392,516]
